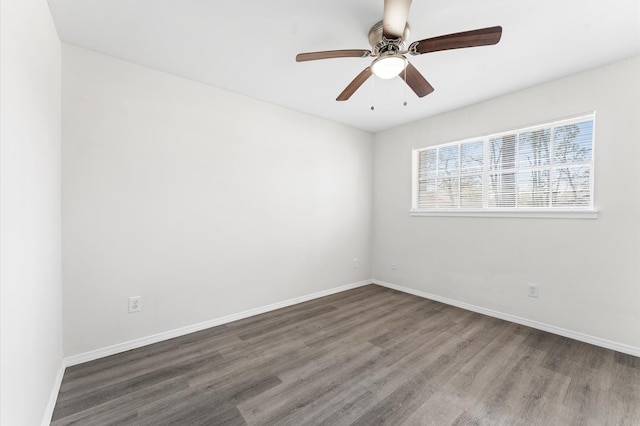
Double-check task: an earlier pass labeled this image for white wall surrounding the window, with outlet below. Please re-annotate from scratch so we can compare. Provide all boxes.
[373,57,640,349]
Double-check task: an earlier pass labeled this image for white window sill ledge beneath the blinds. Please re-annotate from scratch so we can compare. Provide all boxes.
[409,209,598,219]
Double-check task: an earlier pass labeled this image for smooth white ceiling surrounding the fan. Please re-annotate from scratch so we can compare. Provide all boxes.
[49,0,640,132]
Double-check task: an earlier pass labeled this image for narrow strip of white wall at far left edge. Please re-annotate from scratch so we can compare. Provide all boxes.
[0,0,62,426]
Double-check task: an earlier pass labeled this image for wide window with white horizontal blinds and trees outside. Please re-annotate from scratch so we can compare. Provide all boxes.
[411,114,596,217]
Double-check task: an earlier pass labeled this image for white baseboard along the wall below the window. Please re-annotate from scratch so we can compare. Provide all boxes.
[372,280,640,357]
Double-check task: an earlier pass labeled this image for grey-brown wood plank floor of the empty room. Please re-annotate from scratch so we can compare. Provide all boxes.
[52,285,640,426]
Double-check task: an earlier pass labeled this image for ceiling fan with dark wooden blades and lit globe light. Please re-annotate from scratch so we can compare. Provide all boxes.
[296,0,502,101]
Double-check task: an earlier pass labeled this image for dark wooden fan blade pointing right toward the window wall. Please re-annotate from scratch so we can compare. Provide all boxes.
[409,26,502,55]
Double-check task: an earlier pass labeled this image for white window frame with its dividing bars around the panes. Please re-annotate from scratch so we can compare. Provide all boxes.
[409,111,598,219]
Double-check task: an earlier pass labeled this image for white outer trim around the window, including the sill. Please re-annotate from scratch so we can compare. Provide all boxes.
[409,111,599,219]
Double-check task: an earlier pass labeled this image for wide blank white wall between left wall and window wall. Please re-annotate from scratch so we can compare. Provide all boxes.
[62,45,372,355]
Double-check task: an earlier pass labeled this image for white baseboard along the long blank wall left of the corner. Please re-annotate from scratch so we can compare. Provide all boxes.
[63,280,372,366]
